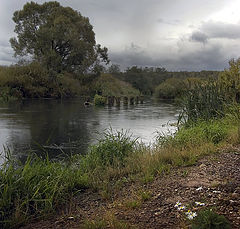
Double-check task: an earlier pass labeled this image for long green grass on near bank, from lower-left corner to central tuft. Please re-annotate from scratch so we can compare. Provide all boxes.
[0,130,136,228]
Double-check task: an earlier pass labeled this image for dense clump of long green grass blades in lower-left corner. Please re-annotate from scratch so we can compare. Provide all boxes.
[0,154,87,228]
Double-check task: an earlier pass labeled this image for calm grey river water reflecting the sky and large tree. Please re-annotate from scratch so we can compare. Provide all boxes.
[0,99,179,161]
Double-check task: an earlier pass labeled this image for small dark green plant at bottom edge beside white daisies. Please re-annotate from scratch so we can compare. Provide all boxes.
[192,209,231,229]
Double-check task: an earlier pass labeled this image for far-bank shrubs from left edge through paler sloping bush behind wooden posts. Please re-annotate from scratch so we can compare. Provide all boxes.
[0,62,139,101]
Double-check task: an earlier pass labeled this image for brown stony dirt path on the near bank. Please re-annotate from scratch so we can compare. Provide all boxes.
[21,148,240,229]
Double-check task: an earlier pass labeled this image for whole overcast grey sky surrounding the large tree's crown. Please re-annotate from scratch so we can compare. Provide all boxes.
[0,0,240,71]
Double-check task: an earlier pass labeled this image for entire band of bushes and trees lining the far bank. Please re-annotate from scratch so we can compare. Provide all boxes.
[0,62,220,101]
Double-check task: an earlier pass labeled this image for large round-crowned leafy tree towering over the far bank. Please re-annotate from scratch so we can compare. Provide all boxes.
[10,2,108,73]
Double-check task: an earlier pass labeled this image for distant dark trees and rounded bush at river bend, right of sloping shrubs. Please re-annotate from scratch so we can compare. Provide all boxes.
[107,65,221,99]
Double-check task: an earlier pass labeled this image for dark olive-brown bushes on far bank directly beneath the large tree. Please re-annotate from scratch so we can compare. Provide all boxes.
[0,62,84,100]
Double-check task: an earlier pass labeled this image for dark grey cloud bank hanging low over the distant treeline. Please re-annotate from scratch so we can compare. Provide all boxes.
[110,41,228,71]
